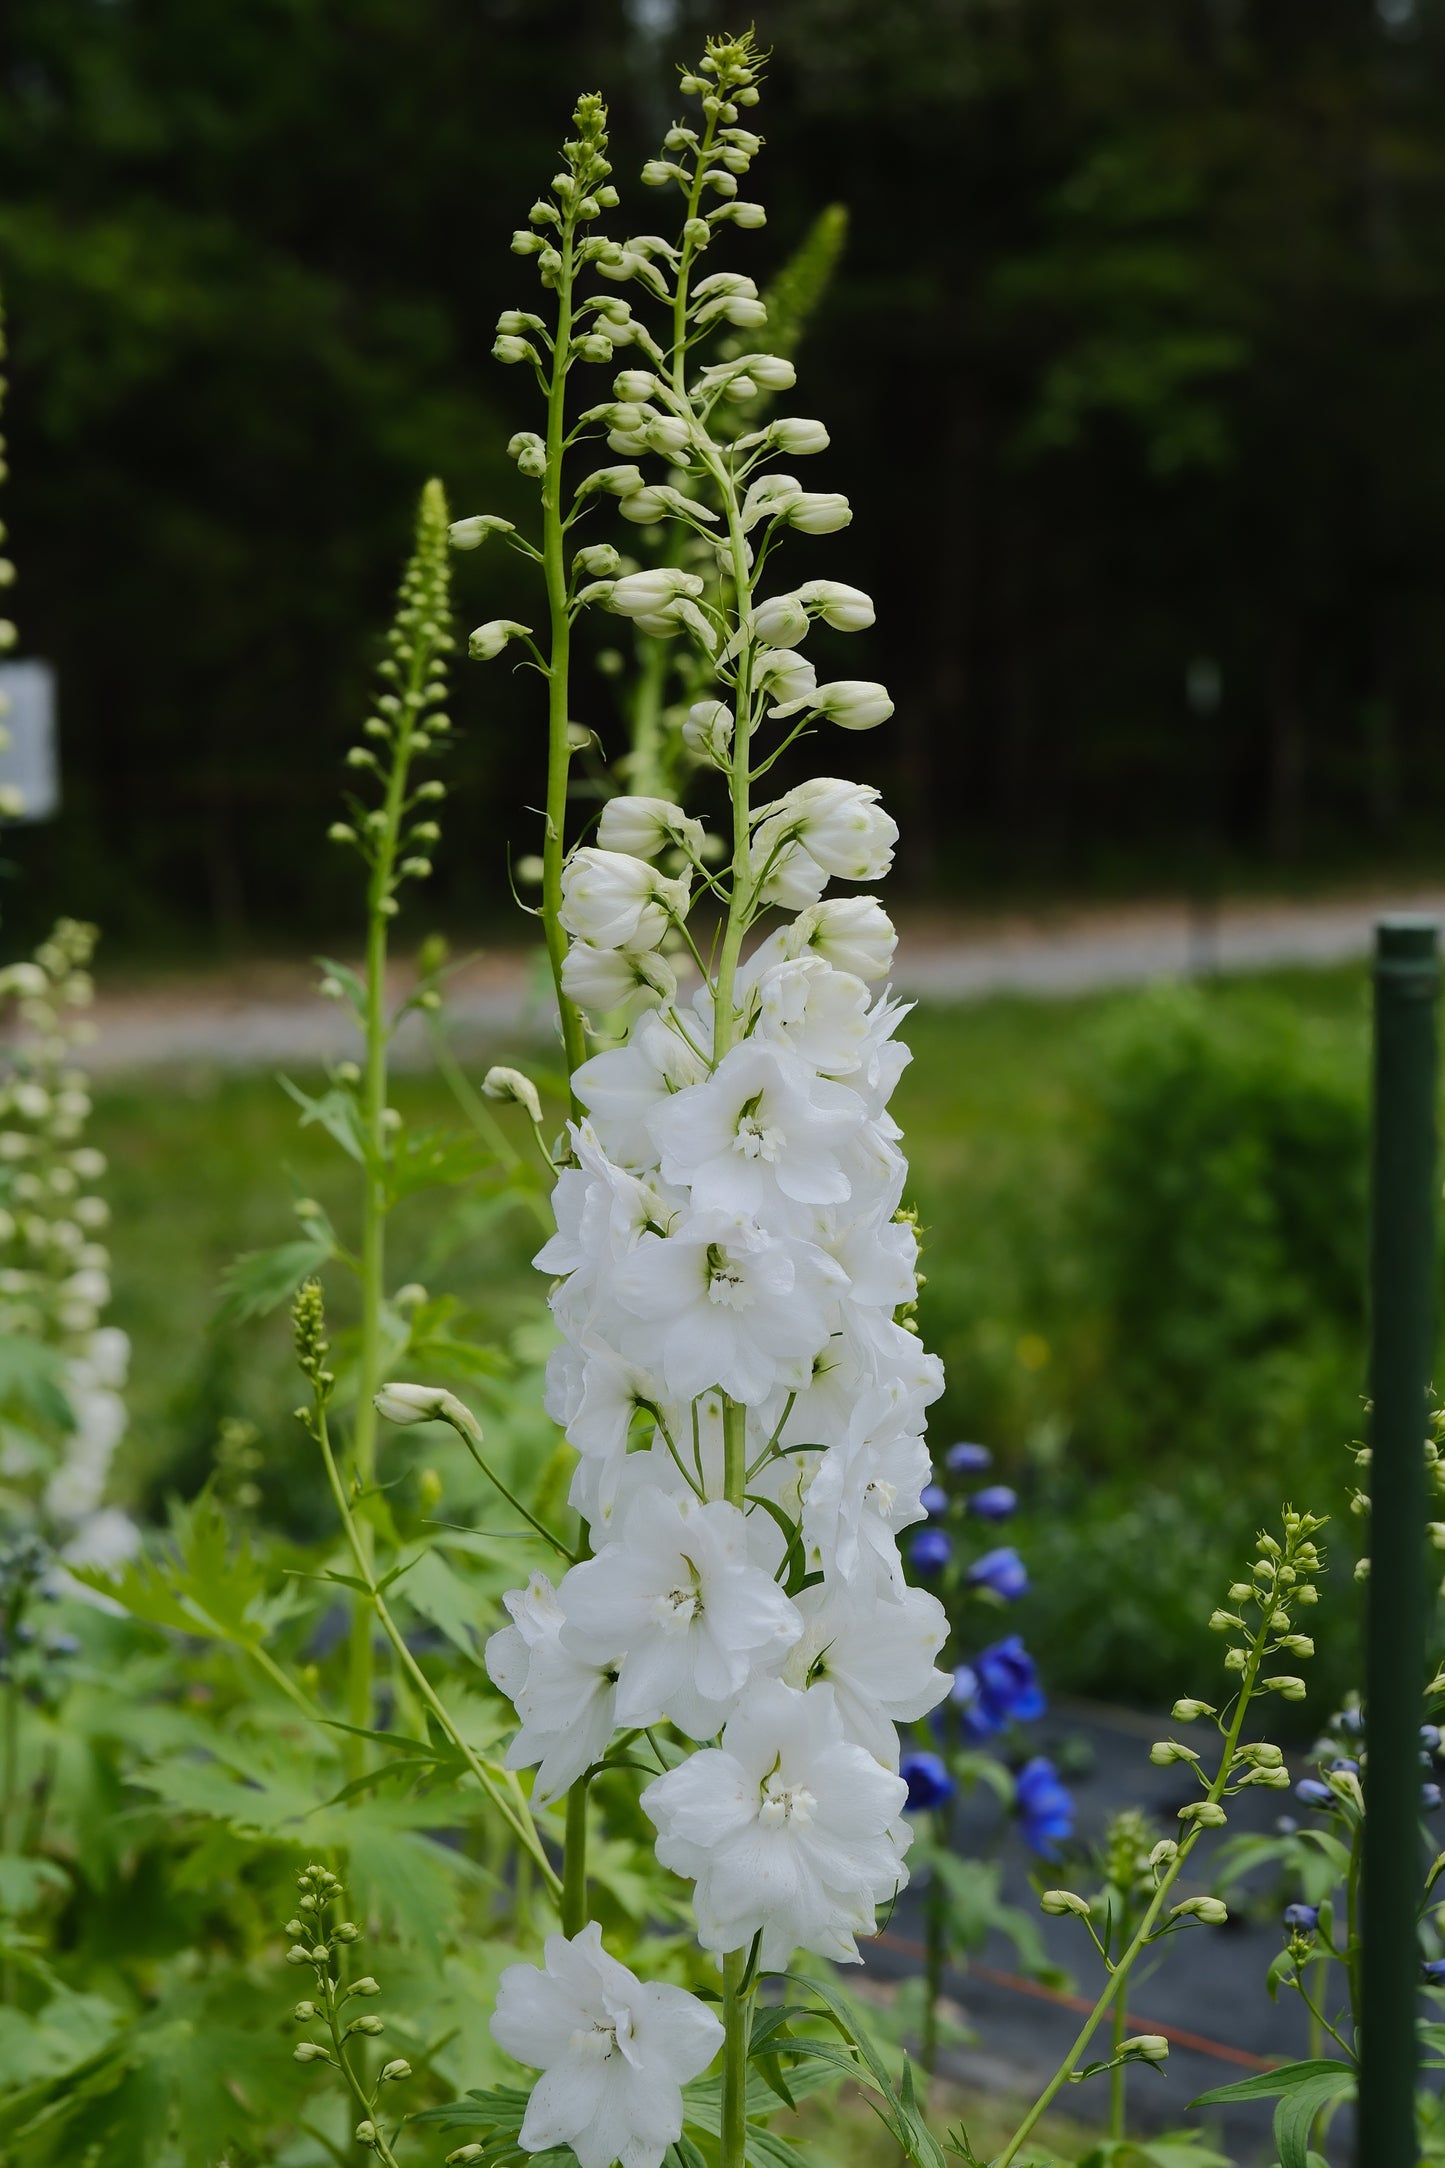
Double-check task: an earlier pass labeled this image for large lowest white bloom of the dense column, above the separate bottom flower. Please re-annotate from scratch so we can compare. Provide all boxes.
[641,1680,912,1971]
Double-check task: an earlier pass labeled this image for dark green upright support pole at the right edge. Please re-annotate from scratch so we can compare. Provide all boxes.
[1356,917,1441,2168]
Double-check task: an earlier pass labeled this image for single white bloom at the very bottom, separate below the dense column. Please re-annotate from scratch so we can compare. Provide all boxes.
[492,1921,724,2168]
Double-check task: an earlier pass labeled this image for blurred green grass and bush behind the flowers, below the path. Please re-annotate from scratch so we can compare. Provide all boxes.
[93,971,1367,1702]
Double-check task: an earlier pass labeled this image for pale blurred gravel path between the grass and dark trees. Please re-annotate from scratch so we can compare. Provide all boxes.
[87,889,1445,1073]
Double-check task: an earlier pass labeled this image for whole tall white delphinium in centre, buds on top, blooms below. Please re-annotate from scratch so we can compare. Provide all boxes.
[470,35,961,2168]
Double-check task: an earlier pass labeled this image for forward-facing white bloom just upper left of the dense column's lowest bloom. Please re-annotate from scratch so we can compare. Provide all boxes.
[557,1489,802,1739]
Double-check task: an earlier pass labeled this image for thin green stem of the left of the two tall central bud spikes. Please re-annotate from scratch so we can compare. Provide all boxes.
[542,233,587,1117]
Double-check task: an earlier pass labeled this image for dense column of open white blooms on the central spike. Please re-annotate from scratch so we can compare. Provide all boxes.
[487,778,947,1969]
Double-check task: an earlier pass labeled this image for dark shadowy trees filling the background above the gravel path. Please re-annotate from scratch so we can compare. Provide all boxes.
[0,0,1445,947]
